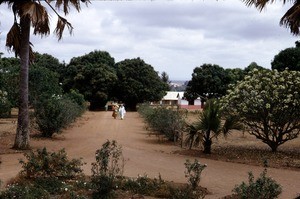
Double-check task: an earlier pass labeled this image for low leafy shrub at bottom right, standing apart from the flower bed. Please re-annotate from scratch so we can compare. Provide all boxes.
[232,169,282,199]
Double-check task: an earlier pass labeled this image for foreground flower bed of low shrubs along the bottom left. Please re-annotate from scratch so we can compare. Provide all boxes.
[0,140,208,199]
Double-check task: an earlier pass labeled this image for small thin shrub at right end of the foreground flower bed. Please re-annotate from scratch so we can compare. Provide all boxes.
[184,159,206,190]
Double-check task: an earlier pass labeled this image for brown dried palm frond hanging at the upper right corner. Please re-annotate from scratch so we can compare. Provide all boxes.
[280,1,300,35]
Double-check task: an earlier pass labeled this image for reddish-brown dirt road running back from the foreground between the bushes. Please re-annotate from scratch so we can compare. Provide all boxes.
[0,112,300,199]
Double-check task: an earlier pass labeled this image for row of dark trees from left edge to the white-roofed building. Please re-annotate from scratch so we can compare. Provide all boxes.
[0,51,169,110]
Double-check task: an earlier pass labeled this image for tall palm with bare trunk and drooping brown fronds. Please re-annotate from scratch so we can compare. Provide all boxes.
[0,0,89,149]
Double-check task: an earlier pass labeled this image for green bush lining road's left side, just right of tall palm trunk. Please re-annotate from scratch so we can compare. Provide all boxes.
[34,91,85,137]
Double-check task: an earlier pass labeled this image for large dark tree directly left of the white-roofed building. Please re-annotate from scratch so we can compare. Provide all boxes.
[114,58,168,110]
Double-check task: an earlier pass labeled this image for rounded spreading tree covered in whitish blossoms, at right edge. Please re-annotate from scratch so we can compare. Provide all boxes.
[222,70,300,151]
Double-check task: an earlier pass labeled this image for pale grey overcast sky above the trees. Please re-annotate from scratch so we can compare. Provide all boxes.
[0,0,299,80]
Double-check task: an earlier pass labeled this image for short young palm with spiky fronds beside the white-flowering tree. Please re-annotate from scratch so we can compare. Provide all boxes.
[185,99,242,154]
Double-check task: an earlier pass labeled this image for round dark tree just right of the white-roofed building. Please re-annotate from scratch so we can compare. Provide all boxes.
[184,64,230,103]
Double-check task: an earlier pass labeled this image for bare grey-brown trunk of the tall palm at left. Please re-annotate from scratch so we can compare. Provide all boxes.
[14,16,30,149]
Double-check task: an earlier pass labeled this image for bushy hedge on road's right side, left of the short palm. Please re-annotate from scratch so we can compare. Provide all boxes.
[138,106,185,141]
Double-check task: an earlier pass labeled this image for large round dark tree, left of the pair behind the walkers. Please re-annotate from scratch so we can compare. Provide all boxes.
[63,51,117,110]
